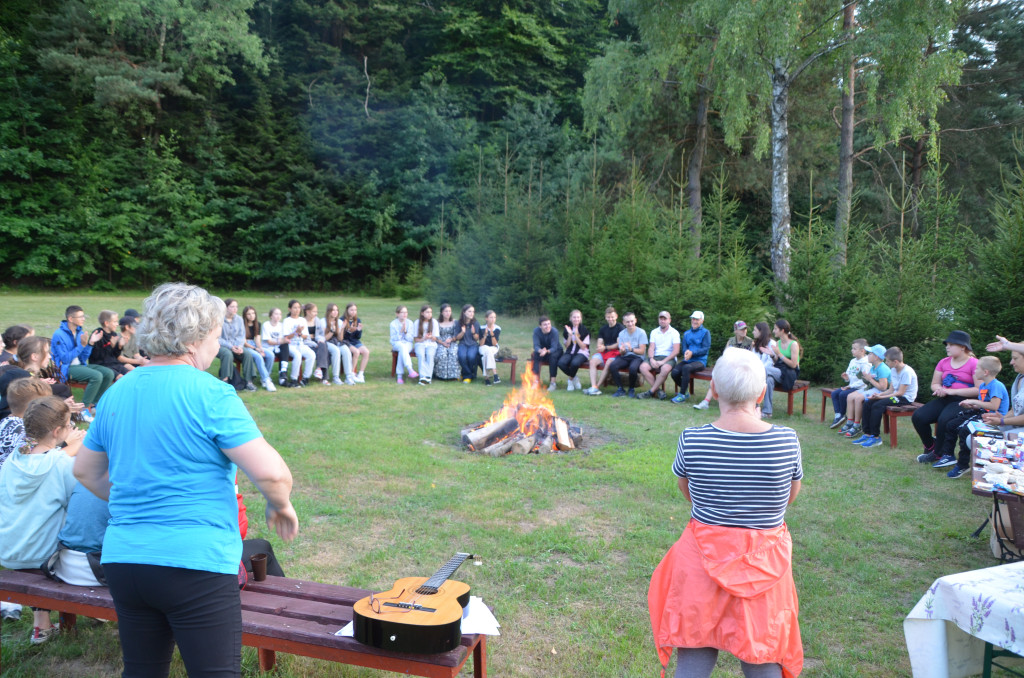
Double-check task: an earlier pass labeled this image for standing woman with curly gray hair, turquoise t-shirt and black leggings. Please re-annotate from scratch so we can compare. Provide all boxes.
[75,283,298,676]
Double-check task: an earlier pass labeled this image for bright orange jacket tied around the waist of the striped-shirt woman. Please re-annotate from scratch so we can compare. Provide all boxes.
[647,519,804,678]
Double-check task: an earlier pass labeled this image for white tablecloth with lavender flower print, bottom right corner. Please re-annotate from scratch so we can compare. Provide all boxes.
[903,562,1024,678]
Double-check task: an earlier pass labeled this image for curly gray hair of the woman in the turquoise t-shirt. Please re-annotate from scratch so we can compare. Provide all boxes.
[137,283,225,356]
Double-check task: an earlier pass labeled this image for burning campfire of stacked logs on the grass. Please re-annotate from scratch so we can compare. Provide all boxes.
[462,370,583,457]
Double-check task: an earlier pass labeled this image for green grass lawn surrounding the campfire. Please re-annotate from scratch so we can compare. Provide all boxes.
[0,293,1024,678]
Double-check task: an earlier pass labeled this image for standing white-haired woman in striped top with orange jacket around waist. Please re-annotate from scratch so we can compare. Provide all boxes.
[647,348,804,678]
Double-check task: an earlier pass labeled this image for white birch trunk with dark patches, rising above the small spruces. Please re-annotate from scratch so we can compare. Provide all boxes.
[771,58,791,283]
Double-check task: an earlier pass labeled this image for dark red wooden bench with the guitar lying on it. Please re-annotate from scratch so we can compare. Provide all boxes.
[0,569,487,678]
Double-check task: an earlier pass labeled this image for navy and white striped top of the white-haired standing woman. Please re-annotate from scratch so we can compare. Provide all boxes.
[672,424,804,529]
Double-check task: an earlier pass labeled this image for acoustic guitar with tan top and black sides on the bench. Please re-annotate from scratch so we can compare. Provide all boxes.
[352,553,473,654]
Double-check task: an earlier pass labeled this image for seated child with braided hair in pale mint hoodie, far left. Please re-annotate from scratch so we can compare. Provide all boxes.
[0,395,85,644]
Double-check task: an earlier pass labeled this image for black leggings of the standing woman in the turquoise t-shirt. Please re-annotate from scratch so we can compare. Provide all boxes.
[103,562,242,678]
